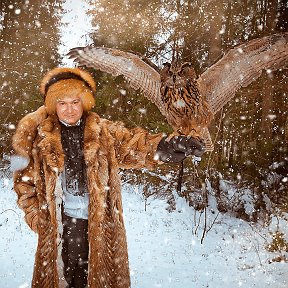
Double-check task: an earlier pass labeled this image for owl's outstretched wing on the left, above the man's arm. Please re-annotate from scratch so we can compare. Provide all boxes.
[67,46,167,117]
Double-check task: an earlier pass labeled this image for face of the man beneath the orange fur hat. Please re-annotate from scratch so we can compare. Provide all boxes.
[56,95,83,125]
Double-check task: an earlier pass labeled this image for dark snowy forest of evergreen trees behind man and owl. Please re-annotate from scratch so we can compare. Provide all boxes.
[0,0,288,221]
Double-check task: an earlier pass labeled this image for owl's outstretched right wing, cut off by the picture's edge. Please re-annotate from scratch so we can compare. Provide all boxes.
[197,32,288,114]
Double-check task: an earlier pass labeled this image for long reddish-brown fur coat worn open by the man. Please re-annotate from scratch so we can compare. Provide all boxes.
[13,107,163,288]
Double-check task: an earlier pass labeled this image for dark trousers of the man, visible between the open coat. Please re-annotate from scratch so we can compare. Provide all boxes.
[62,213,89,288]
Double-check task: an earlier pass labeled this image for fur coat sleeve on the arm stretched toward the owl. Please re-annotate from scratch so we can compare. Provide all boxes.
[109,122,164,169]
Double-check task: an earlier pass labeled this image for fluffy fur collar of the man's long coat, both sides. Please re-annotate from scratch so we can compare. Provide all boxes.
[13,106,104,172]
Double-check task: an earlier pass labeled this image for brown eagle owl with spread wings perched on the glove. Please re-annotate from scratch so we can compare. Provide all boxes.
[68,32,288,151]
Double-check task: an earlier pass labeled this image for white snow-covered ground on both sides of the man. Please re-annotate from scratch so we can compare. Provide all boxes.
[0,178,288,288]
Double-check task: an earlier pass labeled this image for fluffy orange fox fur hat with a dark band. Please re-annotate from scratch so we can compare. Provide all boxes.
[40,68,96,114]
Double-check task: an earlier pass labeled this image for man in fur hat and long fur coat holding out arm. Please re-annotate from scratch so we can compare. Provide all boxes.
[13,68,203,288]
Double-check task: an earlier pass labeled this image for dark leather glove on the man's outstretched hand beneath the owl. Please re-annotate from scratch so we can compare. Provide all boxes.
[156,136,204,163]
